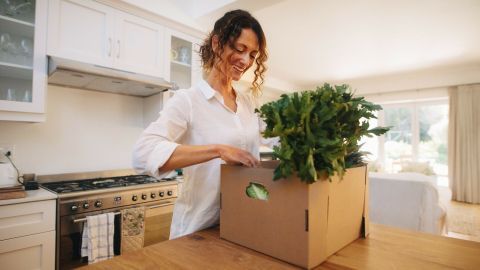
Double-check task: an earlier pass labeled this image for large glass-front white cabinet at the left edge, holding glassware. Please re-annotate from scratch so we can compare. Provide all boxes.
[0,0,47,122]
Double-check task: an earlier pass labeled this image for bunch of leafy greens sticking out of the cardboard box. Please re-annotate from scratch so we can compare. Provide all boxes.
[257,83,389,183]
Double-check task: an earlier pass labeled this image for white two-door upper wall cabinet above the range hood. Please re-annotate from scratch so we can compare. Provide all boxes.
[47,0,165,77]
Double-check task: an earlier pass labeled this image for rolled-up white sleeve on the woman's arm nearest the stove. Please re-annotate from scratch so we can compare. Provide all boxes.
[133,91,191,178]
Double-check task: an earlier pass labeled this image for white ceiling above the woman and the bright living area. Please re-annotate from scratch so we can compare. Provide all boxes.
[124,0,480,93]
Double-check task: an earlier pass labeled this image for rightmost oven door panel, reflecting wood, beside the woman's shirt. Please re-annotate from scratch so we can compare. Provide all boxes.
[144,200,175,247]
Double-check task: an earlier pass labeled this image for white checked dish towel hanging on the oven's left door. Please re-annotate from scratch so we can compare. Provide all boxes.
[81,213,115,264]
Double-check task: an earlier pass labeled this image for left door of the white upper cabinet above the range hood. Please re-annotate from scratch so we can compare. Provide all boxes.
[47,0,115,67]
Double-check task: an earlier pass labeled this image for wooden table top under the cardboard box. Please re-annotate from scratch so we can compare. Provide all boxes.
[82,224,480,270]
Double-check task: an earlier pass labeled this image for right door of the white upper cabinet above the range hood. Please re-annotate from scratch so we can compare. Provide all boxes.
[114,11,164,77]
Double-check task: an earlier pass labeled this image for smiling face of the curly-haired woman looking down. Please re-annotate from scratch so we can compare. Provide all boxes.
[212,28,259,81]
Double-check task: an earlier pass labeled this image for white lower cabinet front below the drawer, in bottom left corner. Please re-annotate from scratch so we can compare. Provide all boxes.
[0,231,55,270]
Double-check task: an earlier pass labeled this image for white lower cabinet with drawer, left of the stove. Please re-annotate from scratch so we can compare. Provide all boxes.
[0,197,56,270]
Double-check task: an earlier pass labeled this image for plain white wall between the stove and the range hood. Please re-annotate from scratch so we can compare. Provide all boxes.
[0,85,143,175]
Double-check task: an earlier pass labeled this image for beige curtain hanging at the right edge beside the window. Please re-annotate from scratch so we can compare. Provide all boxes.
[448,84,480,204]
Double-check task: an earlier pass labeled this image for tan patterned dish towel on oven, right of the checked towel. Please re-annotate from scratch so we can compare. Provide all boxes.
[121,206,145,254]
